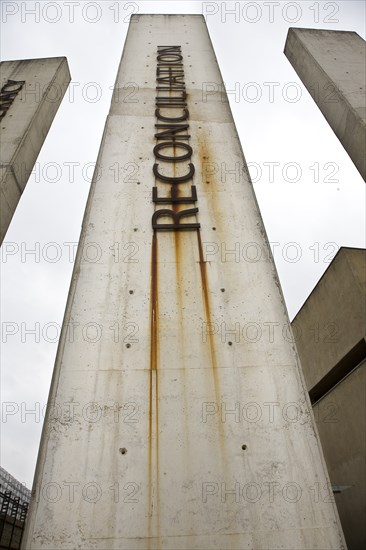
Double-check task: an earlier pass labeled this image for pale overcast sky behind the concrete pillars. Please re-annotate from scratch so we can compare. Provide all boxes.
[0,0,365,492]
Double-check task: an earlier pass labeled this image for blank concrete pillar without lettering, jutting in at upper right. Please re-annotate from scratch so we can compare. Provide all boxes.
[285,28,366,180]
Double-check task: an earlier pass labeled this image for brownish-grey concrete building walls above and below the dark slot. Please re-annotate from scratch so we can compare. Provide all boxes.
[293,248,366,549]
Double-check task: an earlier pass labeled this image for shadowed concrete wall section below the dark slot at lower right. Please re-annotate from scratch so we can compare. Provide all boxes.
[314,361,366,550]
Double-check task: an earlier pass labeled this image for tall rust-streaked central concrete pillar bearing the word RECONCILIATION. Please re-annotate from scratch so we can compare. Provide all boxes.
[24,15,344,550]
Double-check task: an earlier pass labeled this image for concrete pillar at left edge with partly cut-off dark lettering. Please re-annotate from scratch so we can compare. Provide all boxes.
[0,57,70,243]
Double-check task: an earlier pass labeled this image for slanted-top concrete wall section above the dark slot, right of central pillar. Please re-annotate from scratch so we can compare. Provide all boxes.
[292,248,366,390]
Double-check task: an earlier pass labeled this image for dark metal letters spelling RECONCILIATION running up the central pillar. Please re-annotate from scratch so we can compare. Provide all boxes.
[152,46,200,231]
